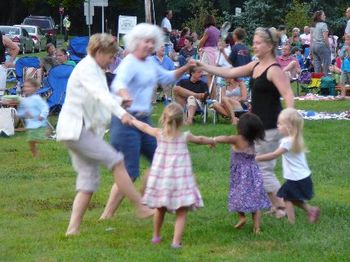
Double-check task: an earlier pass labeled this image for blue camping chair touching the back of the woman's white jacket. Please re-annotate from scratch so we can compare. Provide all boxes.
[41,64,73,113]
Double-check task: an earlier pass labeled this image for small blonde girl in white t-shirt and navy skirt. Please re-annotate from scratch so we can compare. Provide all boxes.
[256,108,320,224]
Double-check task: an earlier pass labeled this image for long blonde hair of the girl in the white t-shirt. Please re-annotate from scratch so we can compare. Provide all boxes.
[278,108,306,153]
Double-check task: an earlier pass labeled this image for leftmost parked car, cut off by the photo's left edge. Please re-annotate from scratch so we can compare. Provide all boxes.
[0,25,34,54]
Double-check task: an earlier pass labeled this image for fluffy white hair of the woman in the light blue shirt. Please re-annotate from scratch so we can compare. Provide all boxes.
[124,23,164,52]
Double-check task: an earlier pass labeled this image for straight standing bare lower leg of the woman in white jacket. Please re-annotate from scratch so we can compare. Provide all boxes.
[66,191,92,236]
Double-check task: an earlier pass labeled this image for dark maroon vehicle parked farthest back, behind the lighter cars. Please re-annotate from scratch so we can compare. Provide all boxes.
[22,15,57,46]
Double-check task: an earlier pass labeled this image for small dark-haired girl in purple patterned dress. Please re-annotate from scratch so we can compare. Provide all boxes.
[214,113,271,234]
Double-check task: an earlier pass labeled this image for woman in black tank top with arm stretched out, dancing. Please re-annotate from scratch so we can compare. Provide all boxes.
[197,28,294,217]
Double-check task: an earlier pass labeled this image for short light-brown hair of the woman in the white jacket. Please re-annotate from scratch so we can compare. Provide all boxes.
[87,33,118,57]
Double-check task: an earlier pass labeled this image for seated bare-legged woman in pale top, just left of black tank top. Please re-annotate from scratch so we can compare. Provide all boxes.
[213,78,248,124]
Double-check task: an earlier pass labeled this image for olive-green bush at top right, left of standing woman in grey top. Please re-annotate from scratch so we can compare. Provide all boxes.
[284,0,311,31]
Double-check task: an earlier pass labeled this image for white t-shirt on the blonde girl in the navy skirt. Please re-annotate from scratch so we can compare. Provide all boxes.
[279,137,311,181]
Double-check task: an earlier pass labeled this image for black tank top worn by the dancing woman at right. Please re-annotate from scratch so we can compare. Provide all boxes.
[249,63,282,130]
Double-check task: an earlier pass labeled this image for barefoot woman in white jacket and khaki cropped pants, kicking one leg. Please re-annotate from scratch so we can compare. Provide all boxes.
[57,34,153,235]
